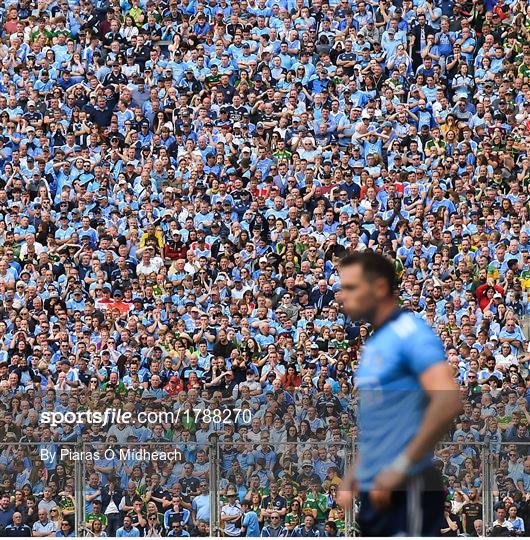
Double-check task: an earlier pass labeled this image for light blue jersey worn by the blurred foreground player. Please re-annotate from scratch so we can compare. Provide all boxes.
[356,311,445,491]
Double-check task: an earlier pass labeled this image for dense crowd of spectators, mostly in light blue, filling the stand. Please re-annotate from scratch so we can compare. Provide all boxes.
[0,0,530,536]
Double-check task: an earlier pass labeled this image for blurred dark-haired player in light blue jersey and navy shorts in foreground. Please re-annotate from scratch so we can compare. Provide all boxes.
[338,252,461,536]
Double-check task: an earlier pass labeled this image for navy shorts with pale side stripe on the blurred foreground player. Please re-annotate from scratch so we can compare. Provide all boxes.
[358,468,445,536]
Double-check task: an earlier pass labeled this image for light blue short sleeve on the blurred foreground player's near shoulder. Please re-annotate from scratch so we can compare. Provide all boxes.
[396,317,445,375]
